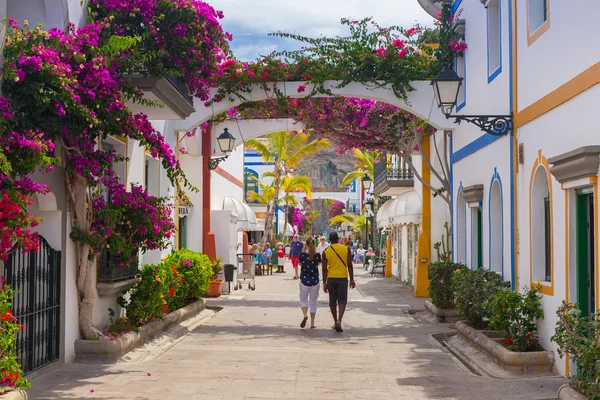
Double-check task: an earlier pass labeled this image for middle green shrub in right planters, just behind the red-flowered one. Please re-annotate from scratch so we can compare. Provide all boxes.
[452,268,510,328]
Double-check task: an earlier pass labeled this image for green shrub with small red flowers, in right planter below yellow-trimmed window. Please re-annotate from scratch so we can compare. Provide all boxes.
[484,287,544,351]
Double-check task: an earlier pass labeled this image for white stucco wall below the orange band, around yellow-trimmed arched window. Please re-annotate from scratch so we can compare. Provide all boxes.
[517,84,600,373]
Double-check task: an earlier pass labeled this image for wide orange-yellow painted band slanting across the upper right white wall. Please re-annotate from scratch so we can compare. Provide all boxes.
[514,62,600,128]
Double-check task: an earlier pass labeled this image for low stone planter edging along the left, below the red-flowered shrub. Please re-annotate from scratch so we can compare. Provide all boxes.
[75,299,206,362]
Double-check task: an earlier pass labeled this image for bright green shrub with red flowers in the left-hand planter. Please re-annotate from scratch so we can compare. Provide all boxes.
[124,249,213,324]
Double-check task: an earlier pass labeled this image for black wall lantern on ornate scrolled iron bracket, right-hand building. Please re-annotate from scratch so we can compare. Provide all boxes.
[431,64,513,136]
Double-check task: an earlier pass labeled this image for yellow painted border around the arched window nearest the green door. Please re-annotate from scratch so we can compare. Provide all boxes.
[529,149,555,296]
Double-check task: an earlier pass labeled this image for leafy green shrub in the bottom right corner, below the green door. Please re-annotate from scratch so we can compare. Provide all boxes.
[550,301,600,400]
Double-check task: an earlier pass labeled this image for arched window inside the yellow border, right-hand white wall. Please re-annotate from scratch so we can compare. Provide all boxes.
[530,165,553,282]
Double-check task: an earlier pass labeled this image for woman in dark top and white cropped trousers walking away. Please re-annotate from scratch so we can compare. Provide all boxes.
[298,238,321,328]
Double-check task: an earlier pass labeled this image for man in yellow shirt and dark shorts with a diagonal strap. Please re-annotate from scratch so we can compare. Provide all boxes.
[323,232,356,332]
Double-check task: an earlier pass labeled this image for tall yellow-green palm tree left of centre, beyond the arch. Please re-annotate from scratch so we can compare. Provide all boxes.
[246,131,331,245]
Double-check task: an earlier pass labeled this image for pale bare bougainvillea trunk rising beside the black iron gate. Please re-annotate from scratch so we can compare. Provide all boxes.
[66,172,96,339]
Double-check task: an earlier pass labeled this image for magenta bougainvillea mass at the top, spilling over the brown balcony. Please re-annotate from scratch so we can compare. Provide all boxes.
[91,0,232,100]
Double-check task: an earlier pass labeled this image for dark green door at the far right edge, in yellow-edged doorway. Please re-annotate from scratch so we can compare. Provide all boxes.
[576,187,596,315]
